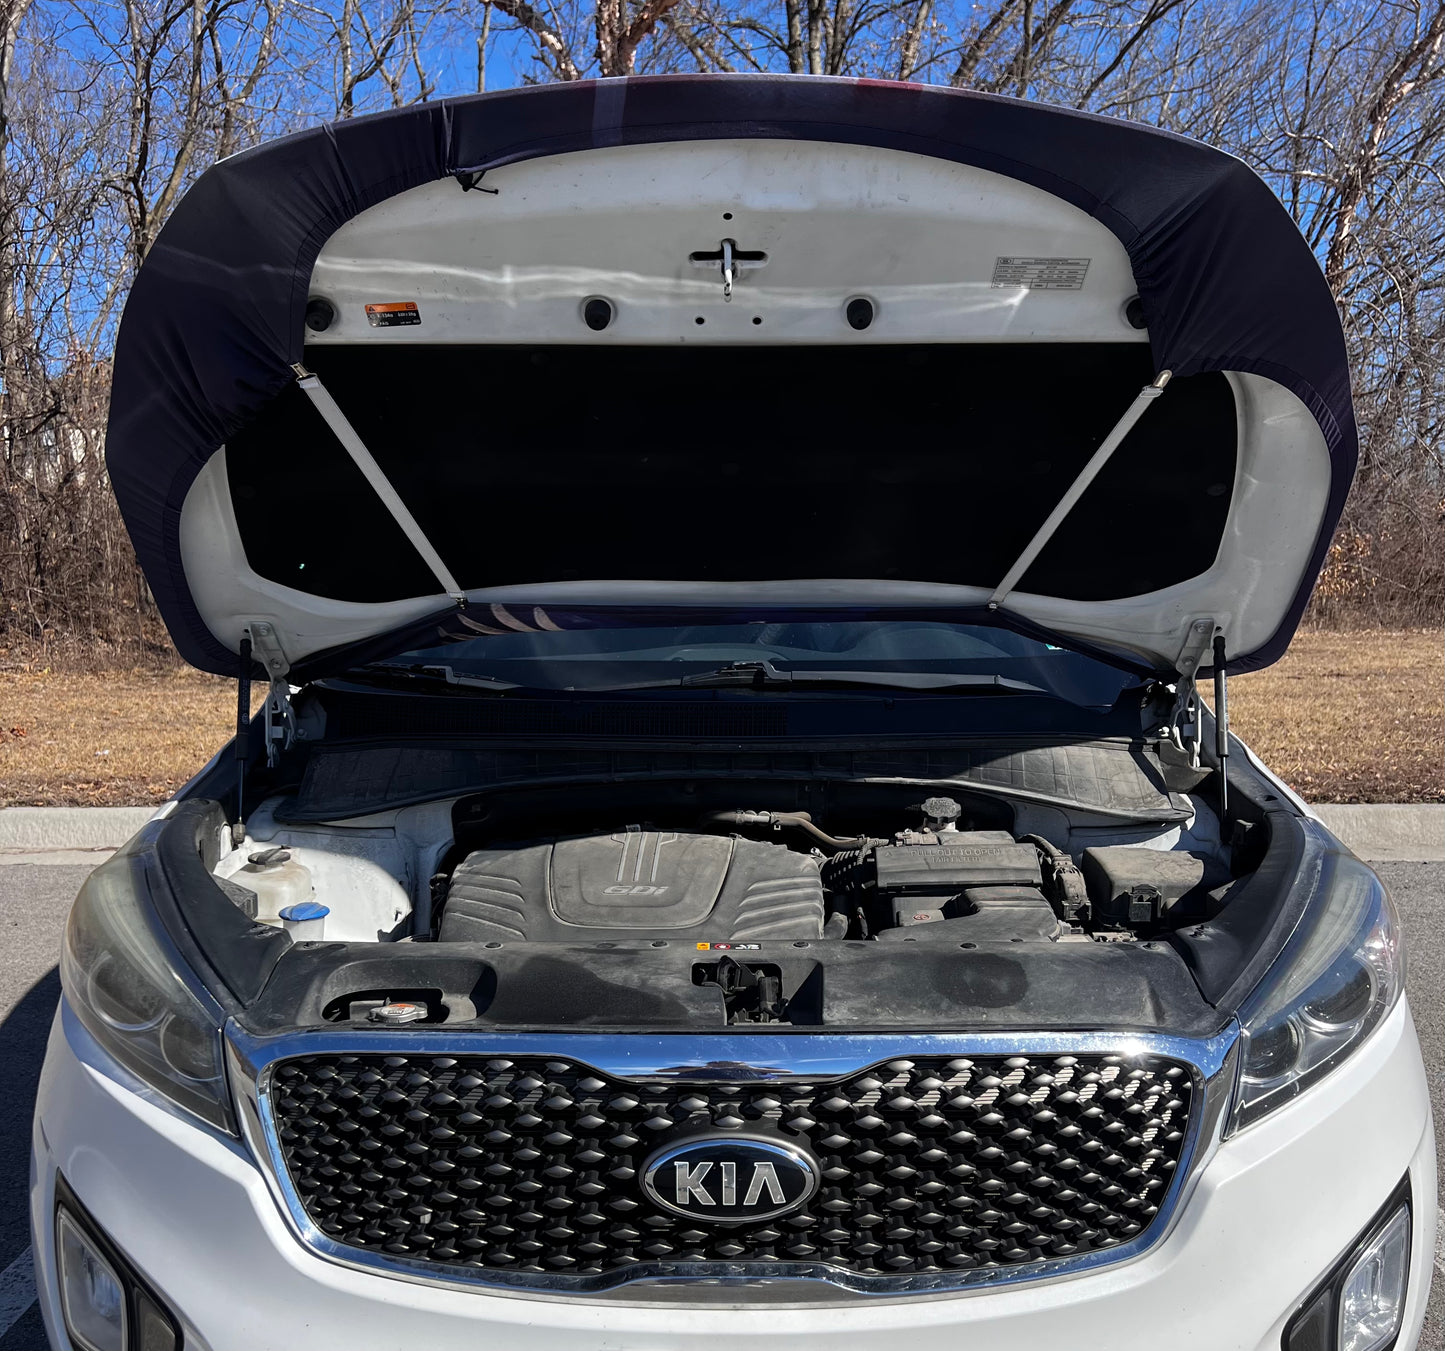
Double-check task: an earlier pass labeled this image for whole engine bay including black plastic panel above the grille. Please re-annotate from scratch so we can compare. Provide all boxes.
[160,773,1296,1035]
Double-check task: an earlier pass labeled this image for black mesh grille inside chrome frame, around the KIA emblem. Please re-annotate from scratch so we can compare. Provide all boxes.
[270,1055,1194,1276]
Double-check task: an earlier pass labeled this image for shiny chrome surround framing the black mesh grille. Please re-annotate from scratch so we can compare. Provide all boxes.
[225,1019,1240,1306]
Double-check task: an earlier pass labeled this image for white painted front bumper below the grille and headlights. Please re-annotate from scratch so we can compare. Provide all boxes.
[30,1001,1436,1351]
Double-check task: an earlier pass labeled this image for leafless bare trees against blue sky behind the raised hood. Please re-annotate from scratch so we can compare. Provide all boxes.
[0,0,1445,655]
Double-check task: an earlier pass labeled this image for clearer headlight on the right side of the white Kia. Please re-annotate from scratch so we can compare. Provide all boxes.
[1233,847,1405,1128]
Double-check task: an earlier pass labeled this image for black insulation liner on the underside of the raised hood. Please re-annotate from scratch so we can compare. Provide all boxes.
[225,344,1235,603]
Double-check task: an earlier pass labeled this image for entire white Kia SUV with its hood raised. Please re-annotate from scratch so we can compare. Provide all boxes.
[32,77,1436,1351]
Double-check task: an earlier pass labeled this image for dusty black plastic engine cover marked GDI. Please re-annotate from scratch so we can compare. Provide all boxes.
[439,831,824,942]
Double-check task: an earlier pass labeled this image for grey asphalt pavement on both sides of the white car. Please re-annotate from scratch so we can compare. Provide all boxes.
[0,863,1445,1351]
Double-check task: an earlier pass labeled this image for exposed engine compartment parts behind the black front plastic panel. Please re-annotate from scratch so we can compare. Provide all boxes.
[215,793,1246,952]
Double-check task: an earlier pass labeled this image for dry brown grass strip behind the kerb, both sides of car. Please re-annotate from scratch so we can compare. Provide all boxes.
[0,630,1445,806]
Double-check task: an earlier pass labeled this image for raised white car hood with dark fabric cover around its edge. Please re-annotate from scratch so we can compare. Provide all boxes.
[107,77,1355,676]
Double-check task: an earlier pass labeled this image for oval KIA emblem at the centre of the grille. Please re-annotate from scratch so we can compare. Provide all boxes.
[642,1136,821,1224]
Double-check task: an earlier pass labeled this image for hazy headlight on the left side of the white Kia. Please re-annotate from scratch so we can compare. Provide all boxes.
[61,850,234,1130]
